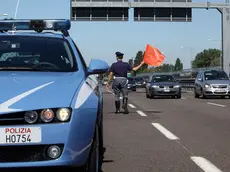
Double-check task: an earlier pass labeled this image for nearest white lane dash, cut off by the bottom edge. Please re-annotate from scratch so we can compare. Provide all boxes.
[191,156,222,172]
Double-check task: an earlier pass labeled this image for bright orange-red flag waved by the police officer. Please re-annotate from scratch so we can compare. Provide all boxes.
[144,44,165,66]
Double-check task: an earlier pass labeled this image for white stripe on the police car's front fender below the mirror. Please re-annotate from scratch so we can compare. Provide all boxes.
[75,78,97,109]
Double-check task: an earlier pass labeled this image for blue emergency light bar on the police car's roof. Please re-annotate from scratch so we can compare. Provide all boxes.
[0,19,71,31]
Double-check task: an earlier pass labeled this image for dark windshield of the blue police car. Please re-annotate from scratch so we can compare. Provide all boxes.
[0,35,77,72]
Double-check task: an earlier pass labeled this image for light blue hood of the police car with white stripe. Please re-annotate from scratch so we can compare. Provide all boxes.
[0,72,82,114]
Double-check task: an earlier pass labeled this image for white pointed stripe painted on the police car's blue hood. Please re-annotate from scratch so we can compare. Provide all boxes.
[0,81,54,112]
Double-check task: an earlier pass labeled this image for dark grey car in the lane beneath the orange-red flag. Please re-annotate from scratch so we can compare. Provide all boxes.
[146,74,181,98]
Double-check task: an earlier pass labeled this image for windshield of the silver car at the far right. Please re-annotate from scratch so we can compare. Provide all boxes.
[204,71,229,80]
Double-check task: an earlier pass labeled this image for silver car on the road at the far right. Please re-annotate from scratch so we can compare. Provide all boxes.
[194,70,230,98]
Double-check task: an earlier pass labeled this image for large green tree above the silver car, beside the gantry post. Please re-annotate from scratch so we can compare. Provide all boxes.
[192,49,221,68]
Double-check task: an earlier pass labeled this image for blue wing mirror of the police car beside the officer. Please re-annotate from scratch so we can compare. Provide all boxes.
[87,59,109,75]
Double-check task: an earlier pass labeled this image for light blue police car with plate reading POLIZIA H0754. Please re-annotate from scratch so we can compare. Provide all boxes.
[0,20,109,172]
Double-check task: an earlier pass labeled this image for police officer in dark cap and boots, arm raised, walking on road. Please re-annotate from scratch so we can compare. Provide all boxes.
[106,52,145,114]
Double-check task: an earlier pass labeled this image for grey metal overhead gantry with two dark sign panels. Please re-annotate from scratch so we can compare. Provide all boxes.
[70,0,230,75]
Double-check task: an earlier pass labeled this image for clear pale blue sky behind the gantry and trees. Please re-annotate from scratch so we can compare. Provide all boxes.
[0,0,225,69]
